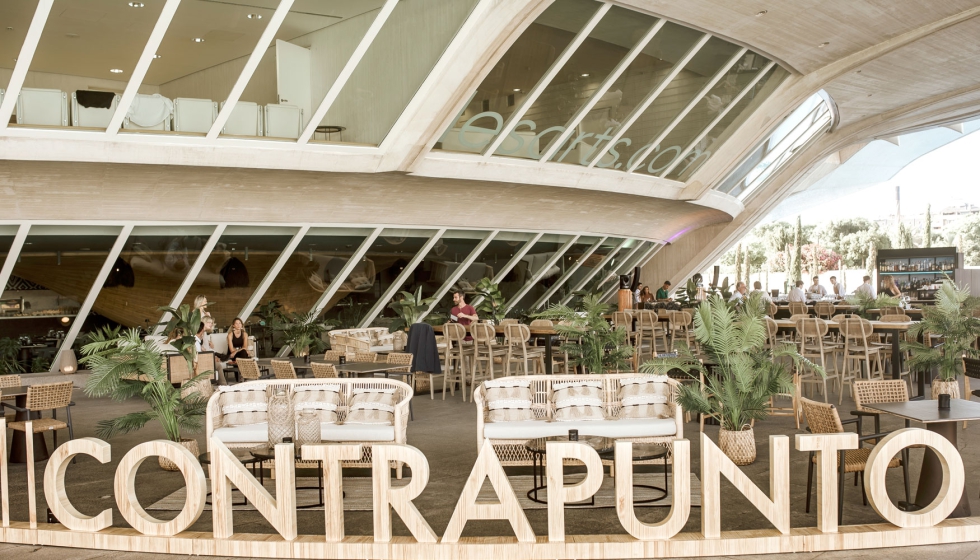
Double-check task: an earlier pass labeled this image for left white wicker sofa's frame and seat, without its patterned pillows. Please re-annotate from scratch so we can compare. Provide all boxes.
[205,378,413,478]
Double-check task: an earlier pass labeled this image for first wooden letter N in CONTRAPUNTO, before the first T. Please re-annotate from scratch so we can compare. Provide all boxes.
[211,437,296,541]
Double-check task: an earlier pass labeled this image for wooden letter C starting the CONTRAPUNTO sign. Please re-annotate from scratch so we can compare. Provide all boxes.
[44,438,112,533]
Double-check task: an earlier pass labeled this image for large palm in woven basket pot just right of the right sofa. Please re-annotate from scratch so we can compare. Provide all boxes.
[640,294,824,465]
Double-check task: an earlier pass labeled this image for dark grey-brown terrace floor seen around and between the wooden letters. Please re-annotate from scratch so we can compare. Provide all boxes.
[0,374,980,560]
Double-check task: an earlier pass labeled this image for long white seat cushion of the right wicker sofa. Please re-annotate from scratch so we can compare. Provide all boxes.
[483,418,677,439]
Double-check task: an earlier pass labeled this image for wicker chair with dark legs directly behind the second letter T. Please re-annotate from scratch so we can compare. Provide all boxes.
[800,398,911,524]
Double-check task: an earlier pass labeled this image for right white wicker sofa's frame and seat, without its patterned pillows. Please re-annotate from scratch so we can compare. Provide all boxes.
[474,373,684,465]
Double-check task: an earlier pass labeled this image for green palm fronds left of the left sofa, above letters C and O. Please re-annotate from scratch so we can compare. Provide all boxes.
[81,329,211,442]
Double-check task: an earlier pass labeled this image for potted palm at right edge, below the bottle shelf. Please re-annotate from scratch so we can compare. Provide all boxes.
[902,278,980,399]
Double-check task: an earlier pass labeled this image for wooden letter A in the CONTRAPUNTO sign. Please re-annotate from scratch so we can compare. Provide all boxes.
[442,439,535,543]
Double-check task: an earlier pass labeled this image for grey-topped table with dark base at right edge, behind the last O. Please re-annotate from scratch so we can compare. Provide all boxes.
[864,399,980,517]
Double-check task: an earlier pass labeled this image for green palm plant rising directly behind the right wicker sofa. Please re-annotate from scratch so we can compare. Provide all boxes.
[534,295,633,373]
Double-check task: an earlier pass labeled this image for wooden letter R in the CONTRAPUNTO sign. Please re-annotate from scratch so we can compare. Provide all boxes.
[371,445,438,543]
